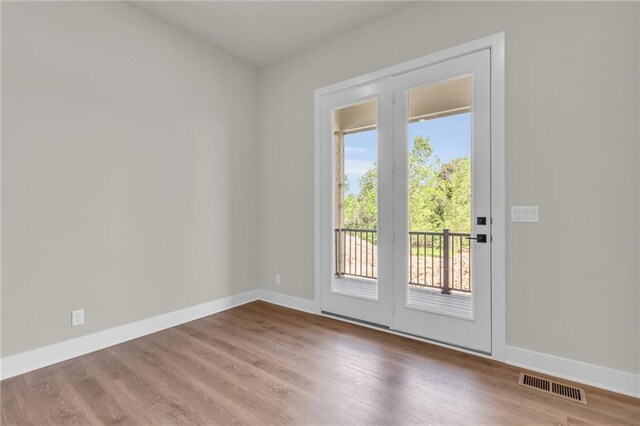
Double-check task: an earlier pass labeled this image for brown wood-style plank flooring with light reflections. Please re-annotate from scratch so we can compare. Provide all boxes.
[0,302,640,425]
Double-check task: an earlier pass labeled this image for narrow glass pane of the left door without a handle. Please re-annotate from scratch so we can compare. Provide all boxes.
[333,99,378,298]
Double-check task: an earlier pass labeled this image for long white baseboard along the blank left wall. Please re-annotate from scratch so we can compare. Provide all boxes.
[0,290,258,380]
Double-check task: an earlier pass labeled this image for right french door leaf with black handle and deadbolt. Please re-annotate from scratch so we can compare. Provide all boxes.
[393,50,491,353]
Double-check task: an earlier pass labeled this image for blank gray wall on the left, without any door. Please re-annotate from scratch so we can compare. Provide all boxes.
[2,2,258,356]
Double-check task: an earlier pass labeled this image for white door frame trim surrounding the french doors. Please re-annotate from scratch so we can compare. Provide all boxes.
[314,32,506,361]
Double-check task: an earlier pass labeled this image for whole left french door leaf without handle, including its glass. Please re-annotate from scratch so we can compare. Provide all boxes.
[320,79,393,326]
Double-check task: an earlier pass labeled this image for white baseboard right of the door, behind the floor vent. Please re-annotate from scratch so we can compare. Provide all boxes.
[506,346,640,398]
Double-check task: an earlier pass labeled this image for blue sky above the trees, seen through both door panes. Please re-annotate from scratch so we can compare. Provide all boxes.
[344,113,471,194]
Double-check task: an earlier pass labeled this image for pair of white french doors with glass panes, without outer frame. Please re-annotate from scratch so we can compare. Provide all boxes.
[316,49,492,353]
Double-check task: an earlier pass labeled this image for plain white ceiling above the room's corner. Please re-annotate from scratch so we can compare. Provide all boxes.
[129,1,412,67]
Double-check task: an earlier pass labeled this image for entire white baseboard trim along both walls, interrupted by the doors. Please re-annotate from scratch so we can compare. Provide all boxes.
[0,289,640,398]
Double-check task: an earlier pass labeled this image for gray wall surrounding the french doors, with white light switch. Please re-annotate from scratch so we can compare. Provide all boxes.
[259,2,640,373]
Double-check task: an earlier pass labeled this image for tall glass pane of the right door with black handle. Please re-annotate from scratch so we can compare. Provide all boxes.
[407,76,473,317]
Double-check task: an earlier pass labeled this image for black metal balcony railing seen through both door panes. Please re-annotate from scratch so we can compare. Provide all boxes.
[334,229,471,294]
